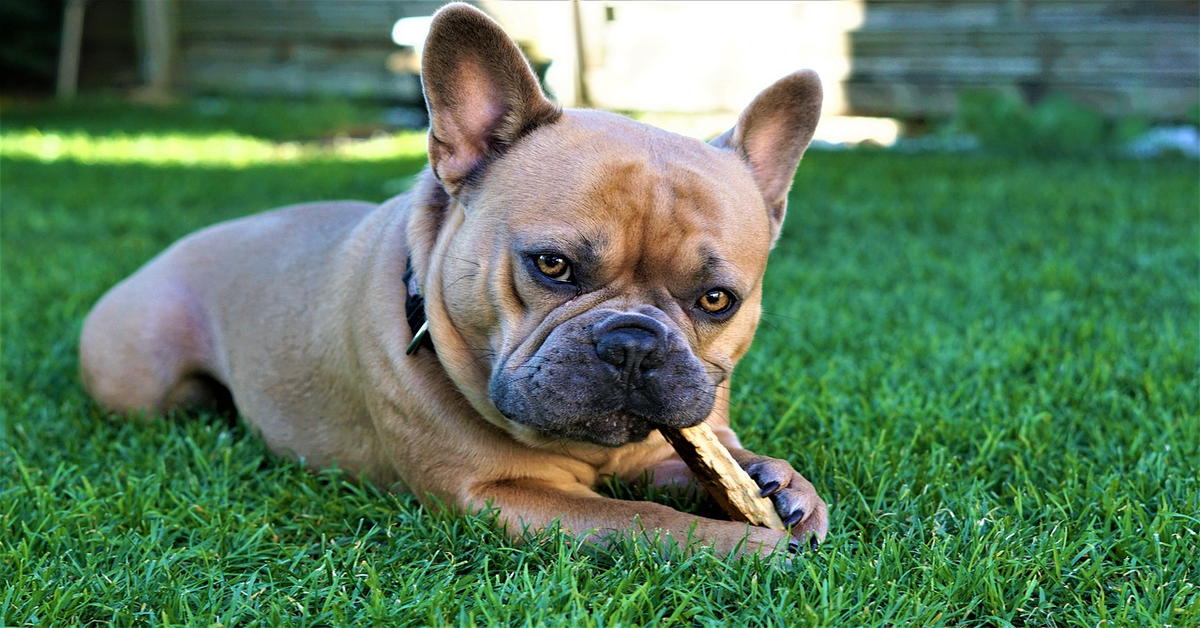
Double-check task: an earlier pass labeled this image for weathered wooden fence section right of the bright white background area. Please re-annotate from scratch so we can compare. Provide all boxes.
[846,0,1200,120]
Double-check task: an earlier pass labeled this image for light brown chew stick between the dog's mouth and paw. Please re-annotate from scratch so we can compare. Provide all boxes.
[659,423,786,531]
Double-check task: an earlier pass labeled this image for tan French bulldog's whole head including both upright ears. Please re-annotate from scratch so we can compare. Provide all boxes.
[410,5,821,447]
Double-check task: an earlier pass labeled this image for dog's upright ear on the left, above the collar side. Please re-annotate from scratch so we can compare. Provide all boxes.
[421,4,559,196]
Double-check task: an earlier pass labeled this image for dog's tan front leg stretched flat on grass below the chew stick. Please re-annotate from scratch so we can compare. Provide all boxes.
[470,479,796,555]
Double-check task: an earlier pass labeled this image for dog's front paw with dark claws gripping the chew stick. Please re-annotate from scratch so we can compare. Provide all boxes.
[743,456,829,549]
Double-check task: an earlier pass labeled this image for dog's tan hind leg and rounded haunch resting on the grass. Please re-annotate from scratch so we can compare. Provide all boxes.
[79,258,233,413]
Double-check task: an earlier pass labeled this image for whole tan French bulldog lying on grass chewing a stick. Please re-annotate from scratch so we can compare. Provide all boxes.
[79,5,828,554]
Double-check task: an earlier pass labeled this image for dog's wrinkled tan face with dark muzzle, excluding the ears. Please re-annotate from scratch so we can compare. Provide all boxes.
[444,112,770,445]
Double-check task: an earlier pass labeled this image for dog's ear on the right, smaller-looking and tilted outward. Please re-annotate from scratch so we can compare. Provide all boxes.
[712,70,821,241]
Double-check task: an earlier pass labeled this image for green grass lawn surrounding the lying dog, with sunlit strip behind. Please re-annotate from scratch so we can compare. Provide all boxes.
[0,98,1200,627]
